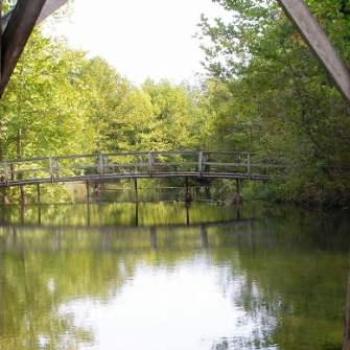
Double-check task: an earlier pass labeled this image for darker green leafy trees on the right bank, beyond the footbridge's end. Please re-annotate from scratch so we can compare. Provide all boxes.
[201,0,350,204]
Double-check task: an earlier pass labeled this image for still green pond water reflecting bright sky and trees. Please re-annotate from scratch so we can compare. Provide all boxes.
[0,203,350,350]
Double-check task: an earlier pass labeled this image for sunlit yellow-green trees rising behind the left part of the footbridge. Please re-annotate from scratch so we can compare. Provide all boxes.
[0,32,208,159]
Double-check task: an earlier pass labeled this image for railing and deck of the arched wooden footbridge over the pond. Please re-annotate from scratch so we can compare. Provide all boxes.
[0,151,285,188]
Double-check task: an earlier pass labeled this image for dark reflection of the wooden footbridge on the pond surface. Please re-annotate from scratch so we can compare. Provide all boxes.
[0,202,255,250]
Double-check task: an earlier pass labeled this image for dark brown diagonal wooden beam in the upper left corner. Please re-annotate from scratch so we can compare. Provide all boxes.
[0,0,46,95]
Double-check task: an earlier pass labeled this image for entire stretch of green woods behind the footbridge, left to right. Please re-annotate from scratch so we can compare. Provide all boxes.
[0,0,350,205]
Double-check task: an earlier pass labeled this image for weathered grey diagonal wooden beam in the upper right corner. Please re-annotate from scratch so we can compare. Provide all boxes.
[278,0,350,101]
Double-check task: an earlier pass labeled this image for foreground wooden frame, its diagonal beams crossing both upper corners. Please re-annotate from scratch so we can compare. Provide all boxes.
[0,0,350,102]
